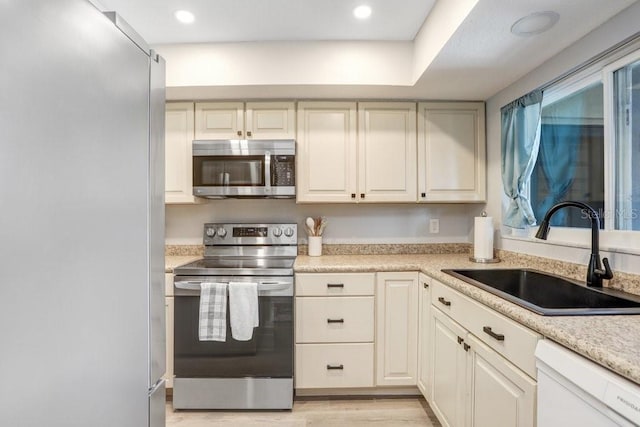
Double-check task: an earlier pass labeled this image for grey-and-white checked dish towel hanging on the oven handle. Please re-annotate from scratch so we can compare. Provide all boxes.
[198,282,227,342]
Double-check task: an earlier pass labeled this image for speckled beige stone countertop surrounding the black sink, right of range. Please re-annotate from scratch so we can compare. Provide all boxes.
[294,254,640,384]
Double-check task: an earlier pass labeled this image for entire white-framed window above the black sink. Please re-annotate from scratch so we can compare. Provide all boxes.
[503,42,640,231]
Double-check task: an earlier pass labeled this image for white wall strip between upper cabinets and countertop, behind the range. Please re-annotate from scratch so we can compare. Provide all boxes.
[165,199,483,245]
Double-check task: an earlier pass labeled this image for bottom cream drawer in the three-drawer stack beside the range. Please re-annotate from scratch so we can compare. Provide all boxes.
[294,343,373,388]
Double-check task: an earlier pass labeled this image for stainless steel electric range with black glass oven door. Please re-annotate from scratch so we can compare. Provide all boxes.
[173,224,298,409]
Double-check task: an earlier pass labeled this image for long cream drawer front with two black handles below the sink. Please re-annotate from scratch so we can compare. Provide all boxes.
[431,280,542,378]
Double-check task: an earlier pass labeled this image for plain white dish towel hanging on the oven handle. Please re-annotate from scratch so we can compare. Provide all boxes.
[229,282,260,341]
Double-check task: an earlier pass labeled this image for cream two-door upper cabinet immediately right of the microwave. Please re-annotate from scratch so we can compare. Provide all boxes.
[297,102,417,203]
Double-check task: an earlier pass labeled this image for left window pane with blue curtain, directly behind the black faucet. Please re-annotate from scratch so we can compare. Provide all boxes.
[530,81,606,228]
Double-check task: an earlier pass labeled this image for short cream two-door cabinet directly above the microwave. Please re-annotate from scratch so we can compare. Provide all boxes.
[195,102,295,139]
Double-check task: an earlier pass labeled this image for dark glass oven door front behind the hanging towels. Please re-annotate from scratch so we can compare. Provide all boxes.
[174,296,293,378]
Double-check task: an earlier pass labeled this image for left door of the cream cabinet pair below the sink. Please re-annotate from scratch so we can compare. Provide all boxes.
[430,307,470,427]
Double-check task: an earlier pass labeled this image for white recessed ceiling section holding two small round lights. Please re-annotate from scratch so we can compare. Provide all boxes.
[98,0,435,44]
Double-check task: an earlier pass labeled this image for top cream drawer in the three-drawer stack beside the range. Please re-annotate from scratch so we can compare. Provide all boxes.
[296,273,375,296]
